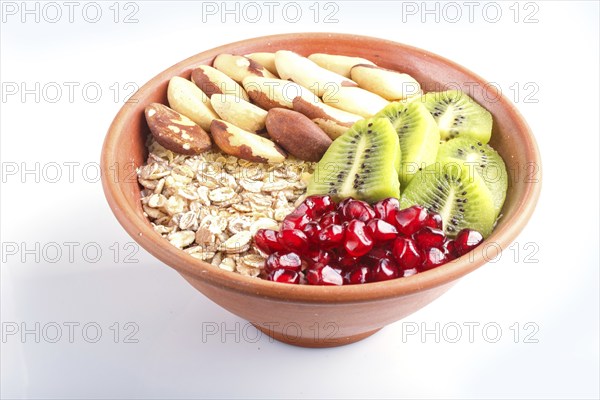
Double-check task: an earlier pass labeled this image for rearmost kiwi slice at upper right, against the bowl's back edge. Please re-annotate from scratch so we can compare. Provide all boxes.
[422,90,492,144]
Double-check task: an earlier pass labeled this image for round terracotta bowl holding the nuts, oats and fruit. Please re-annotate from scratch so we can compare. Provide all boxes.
[101,33,541,347]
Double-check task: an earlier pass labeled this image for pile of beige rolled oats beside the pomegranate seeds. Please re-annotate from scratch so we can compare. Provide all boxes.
[137,141,315,277]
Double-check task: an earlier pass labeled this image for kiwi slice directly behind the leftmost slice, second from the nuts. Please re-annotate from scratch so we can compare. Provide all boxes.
[375,101,440,187]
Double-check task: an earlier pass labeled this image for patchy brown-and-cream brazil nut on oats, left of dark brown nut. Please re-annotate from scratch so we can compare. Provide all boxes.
[210,119,286,163]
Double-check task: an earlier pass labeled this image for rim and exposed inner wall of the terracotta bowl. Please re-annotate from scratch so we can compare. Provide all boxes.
[102,33,540,302]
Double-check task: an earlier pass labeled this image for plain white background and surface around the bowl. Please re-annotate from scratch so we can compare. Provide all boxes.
[0,1,599,398]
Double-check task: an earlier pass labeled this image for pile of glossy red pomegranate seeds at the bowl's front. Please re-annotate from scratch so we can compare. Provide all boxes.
[254,196,483,285]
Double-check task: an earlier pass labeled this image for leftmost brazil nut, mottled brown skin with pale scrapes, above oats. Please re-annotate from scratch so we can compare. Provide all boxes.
[145,103,211,155]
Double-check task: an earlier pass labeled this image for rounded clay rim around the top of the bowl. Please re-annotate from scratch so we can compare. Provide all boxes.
[101,33,541,304]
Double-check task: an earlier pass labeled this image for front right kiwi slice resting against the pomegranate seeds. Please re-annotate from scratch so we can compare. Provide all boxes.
[400,161,496,237]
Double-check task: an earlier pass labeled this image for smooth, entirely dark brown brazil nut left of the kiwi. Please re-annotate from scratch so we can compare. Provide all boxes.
[266,108,331,161]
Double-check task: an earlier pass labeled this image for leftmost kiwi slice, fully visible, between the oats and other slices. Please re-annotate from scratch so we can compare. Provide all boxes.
[307,118,401,202]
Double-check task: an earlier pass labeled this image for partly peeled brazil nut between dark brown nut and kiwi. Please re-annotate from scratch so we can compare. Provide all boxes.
[293,97,363,140]
